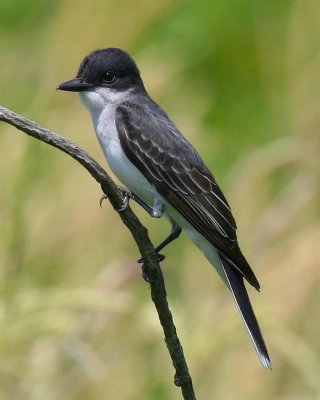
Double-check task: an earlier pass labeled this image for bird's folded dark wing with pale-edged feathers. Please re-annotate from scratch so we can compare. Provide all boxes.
[115,102,259,289]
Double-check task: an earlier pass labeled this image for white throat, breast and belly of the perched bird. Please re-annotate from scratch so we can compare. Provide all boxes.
[80,88,229,286]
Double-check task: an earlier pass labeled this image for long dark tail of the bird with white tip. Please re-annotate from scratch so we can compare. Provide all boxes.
[219,254,272,369]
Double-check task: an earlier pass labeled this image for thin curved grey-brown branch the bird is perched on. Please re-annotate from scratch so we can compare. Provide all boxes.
[0,106,196,400]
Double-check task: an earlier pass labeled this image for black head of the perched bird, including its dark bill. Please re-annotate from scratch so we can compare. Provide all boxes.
[57,48,143,92]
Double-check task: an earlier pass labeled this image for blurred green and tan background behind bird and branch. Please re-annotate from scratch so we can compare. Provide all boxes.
[0,0,320,400]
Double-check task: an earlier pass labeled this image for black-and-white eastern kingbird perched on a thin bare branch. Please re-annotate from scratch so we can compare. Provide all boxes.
[58,48,272,369]
